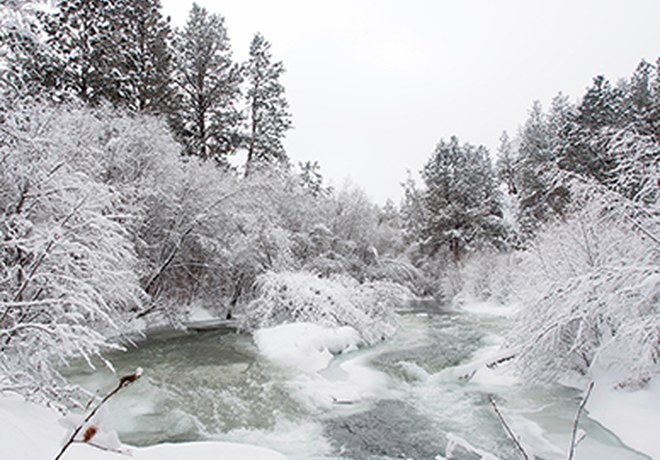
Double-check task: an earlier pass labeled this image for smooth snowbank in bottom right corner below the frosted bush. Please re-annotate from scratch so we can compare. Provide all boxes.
[587,377,660,459]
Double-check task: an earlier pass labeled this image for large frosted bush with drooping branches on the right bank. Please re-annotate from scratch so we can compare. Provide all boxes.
[509,196,660,385]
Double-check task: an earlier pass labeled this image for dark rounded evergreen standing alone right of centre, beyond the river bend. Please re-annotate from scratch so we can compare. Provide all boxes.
[421,136,504,261]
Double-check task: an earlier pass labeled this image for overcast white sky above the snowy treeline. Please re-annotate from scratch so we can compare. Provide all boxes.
[162,0,660,203]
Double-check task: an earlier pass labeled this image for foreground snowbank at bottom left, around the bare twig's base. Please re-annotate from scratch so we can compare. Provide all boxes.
[0,395,286,460]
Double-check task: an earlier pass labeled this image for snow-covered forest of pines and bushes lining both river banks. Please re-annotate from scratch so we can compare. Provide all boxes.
[0,0,660,458]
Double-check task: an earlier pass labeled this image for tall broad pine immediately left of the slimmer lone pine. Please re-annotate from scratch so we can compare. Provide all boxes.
[172,4,241,164]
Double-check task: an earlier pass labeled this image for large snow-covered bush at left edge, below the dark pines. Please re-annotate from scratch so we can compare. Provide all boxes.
[0,100,143,401]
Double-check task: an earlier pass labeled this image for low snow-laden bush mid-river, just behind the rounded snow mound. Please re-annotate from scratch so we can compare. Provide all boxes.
[243,272,410,344]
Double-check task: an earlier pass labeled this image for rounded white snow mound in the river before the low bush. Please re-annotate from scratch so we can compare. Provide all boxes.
[253,323,361,373]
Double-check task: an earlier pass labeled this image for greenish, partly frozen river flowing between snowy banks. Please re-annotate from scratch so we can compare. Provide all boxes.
[66,304,648,460]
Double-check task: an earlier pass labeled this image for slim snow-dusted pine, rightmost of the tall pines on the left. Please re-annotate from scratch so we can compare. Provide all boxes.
[246,34,291,174]
